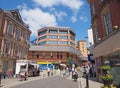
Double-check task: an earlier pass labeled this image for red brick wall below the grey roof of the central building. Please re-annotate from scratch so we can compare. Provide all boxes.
[28,51,77,63]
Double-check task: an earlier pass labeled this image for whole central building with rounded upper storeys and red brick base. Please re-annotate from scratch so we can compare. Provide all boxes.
[28,27,81,68]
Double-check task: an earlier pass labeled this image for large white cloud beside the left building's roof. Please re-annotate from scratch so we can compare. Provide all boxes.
[20,8,57,36]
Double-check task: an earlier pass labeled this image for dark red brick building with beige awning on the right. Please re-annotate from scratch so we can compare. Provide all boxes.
[88,0,120,84]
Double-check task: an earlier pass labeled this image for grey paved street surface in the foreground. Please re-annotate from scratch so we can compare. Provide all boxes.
[1,75,103,88]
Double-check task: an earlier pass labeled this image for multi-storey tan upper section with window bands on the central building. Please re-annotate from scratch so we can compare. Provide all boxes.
[38,27,76,48]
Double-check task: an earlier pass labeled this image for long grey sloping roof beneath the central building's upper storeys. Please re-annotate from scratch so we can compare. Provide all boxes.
[29,45,81,55]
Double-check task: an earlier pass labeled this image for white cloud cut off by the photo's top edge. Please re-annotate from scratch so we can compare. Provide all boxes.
[33,0,84,10]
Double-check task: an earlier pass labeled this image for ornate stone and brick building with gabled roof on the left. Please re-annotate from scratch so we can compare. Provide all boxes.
[0,9,31,72]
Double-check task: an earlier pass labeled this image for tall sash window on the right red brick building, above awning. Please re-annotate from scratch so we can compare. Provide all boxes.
[103,12,112,35]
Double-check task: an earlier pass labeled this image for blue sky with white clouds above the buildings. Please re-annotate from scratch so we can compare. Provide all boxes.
[0,0,91,41]
